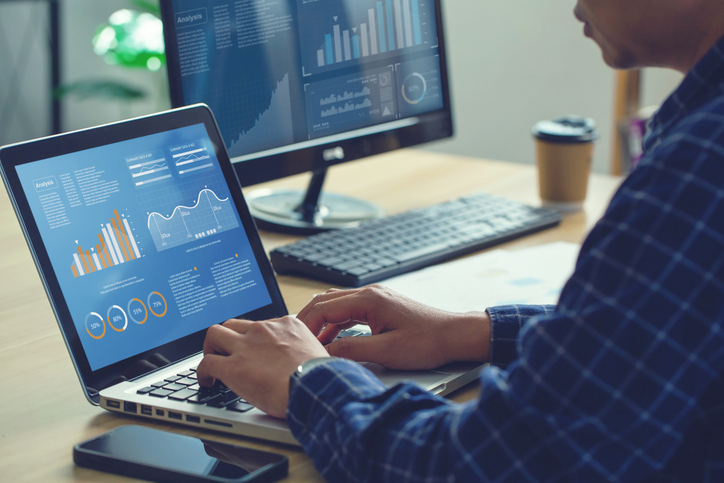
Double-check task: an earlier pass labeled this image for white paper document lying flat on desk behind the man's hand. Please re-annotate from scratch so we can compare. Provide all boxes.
[382,242,581,312]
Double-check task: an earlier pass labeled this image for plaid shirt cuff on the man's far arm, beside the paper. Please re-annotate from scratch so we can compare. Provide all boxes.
[485,305,555,369]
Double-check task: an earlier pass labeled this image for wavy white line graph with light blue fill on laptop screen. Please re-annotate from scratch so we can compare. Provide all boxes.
[148,188,239,252]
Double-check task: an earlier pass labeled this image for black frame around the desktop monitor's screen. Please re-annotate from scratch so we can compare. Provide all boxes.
[160,0,454,186]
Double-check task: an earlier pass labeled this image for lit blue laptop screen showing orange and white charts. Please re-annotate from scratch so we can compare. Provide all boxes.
[16,123,272,371]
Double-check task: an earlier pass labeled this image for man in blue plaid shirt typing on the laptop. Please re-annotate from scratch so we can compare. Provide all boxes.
[198,0,724,482]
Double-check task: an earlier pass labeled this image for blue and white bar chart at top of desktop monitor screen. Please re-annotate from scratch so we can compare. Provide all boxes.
[300,0,435,73]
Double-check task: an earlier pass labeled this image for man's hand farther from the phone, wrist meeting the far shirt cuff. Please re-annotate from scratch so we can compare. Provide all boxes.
[298,285,490,369]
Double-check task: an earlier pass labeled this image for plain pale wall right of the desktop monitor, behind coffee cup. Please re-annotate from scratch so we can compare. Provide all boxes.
[428,0,681,172]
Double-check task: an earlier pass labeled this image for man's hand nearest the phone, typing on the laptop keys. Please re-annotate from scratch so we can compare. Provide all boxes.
[197,316,328,418]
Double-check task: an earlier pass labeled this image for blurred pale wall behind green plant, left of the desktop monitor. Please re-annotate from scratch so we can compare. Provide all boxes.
[0,0,170,144]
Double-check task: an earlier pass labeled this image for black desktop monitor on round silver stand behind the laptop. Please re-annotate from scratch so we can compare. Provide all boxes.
[161,0,453,233]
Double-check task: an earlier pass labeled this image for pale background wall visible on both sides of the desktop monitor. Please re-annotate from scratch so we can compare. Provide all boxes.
[0,0,680,172]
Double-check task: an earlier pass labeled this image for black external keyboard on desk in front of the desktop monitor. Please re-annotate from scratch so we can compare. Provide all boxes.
[271,193,561,287]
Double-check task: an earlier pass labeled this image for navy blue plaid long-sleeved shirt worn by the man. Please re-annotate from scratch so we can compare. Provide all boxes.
[288,39,724,482]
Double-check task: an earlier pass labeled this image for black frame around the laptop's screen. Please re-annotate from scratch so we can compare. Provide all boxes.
[0,104,288,404]
